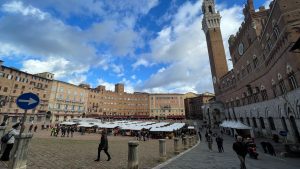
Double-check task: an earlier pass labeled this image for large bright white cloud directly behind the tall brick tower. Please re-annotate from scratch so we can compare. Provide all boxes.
[137,1,243,93]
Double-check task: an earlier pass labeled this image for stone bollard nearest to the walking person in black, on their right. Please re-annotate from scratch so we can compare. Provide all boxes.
[127,141,139,169]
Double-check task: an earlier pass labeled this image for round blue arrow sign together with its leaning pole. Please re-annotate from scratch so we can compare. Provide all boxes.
[9,93,40,169]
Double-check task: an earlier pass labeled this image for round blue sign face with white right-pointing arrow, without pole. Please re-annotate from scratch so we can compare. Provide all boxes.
[16,93,40,110]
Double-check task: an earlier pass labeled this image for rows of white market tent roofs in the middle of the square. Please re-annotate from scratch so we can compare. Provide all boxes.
[61,119,189,132]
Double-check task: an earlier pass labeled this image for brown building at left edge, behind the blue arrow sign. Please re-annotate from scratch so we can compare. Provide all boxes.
[0,61,51,122]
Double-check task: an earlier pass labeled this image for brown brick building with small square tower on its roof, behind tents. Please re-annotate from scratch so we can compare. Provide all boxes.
[87,84,150,119]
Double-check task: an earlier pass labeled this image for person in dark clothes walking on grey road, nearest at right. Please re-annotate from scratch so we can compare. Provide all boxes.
[232,136,247,169]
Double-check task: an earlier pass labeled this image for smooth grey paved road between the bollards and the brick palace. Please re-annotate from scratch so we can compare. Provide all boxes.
[160,131,300,169]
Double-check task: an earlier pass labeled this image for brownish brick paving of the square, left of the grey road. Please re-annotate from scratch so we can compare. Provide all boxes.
[0,131,185,169]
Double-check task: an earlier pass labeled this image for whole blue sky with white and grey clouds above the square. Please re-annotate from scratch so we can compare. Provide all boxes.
[0,0,270,93]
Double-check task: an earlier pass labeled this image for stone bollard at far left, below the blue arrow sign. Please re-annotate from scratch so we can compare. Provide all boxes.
[8,133,33,169]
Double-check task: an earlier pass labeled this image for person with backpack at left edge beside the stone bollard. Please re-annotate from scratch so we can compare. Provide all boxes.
[0,123,20,161]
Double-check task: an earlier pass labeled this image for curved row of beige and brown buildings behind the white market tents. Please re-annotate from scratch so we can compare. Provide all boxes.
[0,62,190,123]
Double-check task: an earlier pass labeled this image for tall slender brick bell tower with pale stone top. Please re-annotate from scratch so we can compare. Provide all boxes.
[202,0,228,96]
